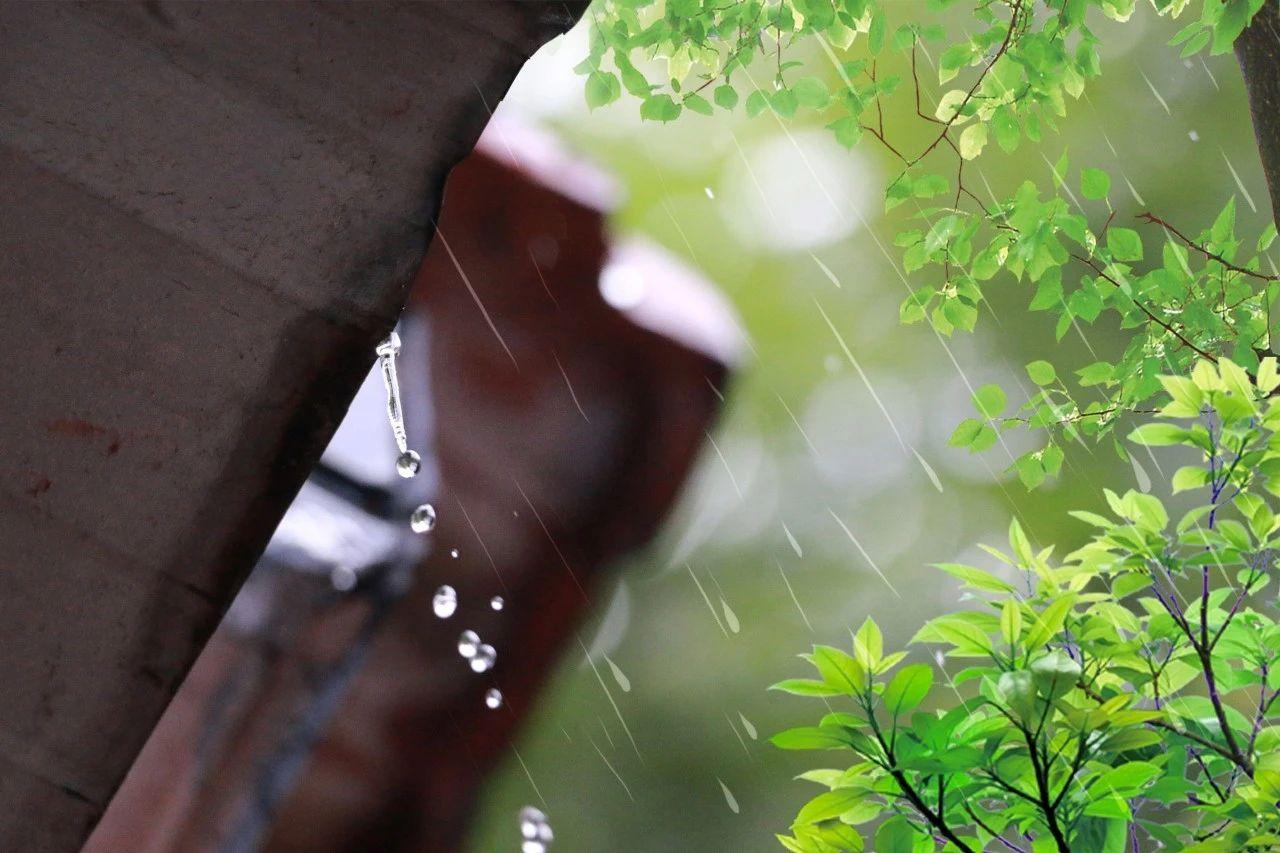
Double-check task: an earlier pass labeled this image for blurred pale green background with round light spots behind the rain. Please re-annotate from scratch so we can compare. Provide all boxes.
[471,3,1270,853]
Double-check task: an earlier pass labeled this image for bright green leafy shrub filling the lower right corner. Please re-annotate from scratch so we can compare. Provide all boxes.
[774,357,1280,853]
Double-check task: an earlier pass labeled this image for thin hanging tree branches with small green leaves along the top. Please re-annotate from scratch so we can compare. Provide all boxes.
[577,0,1280,488]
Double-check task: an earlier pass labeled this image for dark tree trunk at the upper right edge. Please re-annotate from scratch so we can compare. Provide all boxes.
[1235,0,1280,218]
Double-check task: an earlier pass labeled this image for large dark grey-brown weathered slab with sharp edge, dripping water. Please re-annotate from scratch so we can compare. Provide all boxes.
[0,3,571,850]
